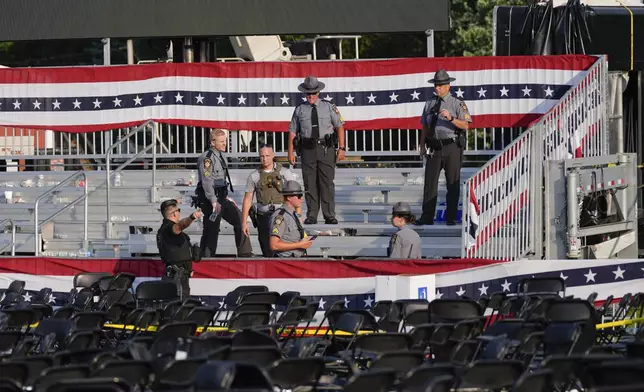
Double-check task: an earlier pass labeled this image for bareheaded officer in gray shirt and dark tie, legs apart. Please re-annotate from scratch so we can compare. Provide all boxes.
[196,129,253,257]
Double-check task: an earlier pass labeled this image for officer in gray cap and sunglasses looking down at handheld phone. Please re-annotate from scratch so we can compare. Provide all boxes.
[270,181,313,257]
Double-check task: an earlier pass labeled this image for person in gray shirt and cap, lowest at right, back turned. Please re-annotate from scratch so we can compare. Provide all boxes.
[387,202,421,259]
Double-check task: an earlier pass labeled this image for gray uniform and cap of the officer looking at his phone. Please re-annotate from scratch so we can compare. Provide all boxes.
[271,181,306,257]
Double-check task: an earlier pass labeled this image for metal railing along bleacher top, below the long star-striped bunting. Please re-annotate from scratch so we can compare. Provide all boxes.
[0,123,525,170]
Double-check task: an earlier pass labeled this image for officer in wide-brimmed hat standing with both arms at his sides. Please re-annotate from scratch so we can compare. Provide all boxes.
[288,76,346,224]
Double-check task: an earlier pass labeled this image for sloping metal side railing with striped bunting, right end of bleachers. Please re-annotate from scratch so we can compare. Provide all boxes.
[462,56,609,260]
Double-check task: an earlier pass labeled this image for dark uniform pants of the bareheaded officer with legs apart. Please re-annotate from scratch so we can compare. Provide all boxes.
[201,199,253,257]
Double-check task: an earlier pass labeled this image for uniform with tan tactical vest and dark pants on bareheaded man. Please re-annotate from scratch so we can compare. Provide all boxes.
[245,163,295,257]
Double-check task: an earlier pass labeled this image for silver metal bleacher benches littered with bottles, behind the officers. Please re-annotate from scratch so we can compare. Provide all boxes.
[0,168,475,258]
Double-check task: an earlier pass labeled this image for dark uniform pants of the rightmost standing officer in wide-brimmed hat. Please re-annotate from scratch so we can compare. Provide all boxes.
[420,143,463,222]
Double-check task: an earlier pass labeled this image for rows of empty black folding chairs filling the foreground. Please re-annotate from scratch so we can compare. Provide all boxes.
[0,273,644,392]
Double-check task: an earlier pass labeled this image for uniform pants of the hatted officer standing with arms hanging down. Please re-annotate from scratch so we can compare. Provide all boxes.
[302,145,336,221]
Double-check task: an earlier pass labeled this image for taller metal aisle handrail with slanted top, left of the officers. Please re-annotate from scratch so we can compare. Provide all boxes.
[105,120,158,239]
